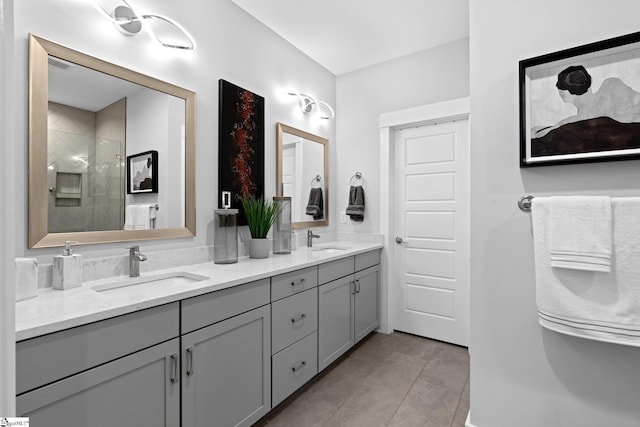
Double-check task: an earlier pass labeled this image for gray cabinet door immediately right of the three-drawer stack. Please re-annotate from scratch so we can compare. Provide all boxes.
[318,274,355,370]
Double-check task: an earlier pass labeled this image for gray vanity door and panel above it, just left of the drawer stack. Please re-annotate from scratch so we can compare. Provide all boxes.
[181,279,271,427]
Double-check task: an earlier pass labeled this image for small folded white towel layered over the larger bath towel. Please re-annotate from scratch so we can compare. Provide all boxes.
[549,196,611,272]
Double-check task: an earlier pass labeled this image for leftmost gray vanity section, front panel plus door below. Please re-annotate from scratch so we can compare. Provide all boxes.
[16,303,180,427]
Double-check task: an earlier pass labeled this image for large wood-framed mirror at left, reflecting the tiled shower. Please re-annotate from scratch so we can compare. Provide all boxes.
[29,35,196,248]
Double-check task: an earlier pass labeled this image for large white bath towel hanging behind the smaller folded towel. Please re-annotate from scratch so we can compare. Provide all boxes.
[532,197,640,347]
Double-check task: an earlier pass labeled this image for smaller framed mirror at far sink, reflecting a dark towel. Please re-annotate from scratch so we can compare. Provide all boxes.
[276,123,329,228]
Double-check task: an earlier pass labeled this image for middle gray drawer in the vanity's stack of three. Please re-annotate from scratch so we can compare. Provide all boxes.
[271,288,318,354]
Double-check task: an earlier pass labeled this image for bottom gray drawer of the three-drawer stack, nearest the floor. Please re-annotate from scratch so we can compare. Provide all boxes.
[271,332,318,407]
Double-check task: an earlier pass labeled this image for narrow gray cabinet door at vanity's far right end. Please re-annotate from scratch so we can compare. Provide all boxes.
[354,266,380,342]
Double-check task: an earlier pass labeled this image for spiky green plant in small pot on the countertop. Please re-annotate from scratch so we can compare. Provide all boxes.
[241,195,280,258]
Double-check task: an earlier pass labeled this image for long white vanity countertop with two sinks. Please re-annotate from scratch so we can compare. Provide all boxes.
[16,241,383,341]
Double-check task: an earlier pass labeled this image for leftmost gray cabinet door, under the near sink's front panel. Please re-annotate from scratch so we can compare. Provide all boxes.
[16,338,180,427]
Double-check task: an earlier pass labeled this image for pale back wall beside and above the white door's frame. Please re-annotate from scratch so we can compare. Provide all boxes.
[338,39,469,233]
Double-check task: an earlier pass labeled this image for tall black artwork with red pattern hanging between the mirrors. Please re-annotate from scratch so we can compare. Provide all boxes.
[218,79,264,225]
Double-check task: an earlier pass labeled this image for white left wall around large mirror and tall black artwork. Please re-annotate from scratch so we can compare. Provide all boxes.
[12,0,335,263]
